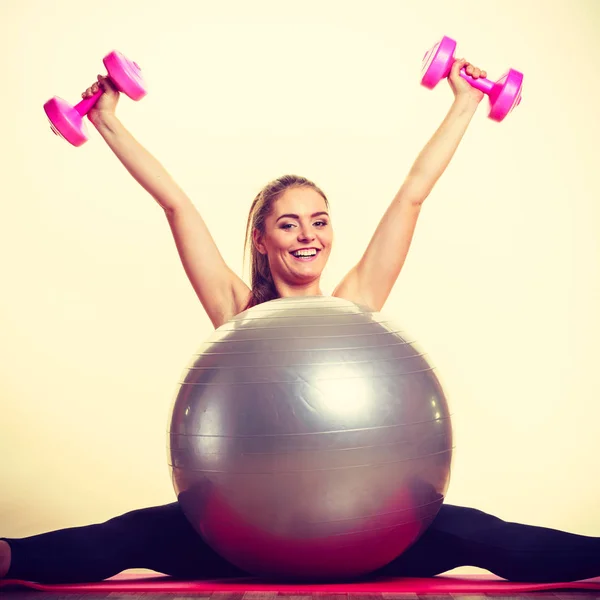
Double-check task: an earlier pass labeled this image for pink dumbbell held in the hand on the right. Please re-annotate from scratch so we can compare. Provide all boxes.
[421,36,523,121]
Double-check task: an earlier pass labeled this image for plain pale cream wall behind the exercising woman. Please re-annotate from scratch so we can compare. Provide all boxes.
[0,0,600,576]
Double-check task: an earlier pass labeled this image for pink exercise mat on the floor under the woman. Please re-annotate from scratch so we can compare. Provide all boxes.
[0,571,600,595]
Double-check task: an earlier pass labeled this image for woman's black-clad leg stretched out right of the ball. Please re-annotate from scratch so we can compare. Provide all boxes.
[377,505,600,582]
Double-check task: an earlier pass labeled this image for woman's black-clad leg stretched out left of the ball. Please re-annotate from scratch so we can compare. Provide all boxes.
[3,502,244,583]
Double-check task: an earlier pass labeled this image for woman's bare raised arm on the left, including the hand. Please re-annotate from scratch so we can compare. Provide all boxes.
[84,77,250,327]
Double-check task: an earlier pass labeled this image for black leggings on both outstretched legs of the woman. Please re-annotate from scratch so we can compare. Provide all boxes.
[2,502,600,583]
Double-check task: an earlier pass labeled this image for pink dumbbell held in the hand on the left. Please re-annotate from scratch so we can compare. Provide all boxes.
[44,50,146,146]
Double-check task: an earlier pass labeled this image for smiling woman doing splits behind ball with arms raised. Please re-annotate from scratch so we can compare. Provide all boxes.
[0,60,600,583]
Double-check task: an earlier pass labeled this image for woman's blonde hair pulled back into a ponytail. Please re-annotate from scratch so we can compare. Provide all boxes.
[244,175,329,308]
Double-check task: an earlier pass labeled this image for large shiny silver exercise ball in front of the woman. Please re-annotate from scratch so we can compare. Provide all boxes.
[169,296,452,580]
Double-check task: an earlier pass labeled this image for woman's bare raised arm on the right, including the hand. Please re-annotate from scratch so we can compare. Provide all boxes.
[333,60,485,310]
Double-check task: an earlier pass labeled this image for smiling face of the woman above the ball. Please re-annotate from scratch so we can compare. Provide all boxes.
[256,188,333,285]
